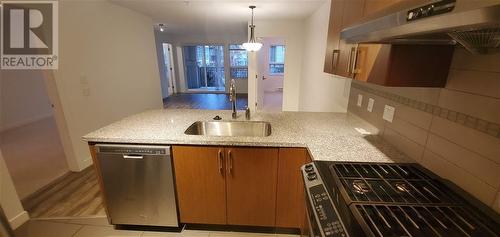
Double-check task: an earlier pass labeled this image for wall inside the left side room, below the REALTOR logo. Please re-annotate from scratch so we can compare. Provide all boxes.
[0,70,52,132]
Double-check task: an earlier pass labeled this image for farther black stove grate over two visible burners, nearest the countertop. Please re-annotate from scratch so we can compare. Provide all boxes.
[330,163,459,204]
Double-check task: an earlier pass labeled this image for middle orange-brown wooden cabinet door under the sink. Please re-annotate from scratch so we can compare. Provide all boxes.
[226,148,278,227]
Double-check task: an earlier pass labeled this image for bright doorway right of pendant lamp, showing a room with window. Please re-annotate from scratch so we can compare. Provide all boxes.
[257,37,286,111]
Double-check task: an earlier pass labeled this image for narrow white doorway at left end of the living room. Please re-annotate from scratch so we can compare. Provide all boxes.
[160,43,175,99]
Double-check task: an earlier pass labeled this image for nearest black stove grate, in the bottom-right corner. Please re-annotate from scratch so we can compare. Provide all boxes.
[352,204,497,237]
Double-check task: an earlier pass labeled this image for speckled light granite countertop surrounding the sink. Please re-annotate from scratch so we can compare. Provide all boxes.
[83,109,410,162]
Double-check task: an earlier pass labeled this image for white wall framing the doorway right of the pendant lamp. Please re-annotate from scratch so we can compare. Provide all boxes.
[248,20,304,111]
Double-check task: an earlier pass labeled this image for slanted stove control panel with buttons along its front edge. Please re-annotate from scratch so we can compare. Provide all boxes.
[302,163,349,237]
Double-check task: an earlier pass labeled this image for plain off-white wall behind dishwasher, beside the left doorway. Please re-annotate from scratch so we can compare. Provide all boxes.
[52,0,162,171]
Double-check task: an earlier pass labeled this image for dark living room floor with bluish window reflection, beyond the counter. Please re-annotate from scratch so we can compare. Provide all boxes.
[163,94,248,110]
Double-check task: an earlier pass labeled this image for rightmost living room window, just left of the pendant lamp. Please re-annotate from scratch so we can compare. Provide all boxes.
[229,44,248,79]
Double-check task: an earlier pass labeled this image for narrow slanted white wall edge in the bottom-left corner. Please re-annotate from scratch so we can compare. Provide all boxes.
[0,151,29,229]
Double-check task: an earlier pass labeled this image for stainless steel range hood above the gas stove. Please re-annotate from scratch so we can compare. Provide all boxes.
[340,0,500,54]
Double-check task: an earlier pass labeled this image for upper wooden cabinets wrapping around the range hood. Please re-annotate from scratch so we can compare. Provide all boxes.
[324,0,454,87]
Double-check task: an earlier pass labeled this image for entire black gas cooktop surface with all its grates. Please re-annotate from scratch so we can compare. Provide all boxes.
[329,162,500,237]
